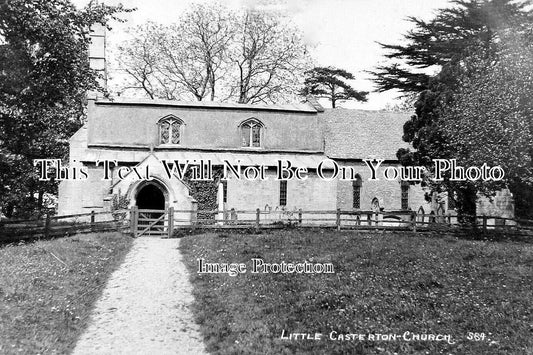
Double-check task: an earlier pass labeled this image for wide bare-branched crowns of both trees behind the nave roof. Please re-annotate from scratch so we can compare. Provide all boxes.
[119,4,308,103]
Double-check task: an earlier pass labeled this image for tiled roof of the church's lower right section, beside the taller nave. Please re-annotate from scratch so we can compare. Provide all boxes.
[321,108,411,160]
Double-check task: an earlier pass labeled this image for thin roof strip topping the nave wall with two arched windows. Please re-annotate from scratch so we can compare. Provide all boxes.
[96,98,317,113]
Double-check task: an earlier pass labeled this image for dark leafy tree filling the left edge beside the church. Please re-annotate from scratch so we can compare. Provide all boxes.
[0,0,126,217]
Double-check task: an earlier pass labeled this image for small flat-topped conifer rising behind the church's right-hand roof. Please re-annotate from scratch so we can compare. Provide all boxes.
[301,67,368,108]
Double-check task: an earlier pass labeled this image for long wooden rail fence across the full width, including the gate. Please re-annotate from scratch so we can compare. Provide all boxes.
[0,207,533,242]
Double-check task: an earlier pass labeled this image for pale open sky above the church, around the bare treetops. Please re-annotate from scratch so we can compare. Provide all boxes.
[73,0,450,110]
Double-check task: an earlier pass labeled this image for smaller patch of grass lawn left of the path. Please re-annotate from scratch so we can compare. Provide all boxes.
[0,233,132,354]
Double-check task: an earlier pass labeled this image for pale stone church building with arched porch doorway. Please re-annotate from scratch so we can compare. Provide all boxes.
[58,97,512,222]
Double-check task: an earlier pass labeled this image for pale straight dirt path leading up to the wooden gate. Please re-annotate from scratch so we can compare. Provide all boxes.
[73,238,206,355]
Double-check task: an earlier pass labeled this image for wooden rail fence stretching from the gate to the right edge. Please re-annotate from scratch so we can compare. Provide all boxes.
[170,209,533,234]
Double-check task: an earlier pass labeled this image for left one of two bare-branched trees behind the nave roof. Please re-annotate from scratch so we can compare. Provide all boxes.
[119,5,235,101]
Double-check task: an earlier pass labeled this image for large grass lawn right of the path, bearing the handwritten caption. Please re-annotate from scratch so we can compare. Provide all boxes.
[181,230,533,354]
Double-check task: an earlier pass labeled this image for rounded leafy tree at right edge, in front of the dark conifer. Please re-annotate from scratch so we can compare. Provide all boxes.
[442,27,533,218]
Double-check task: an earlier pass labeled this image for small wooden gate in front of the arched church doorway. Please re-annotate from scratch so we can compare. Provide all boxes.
[131,207,174,238]
